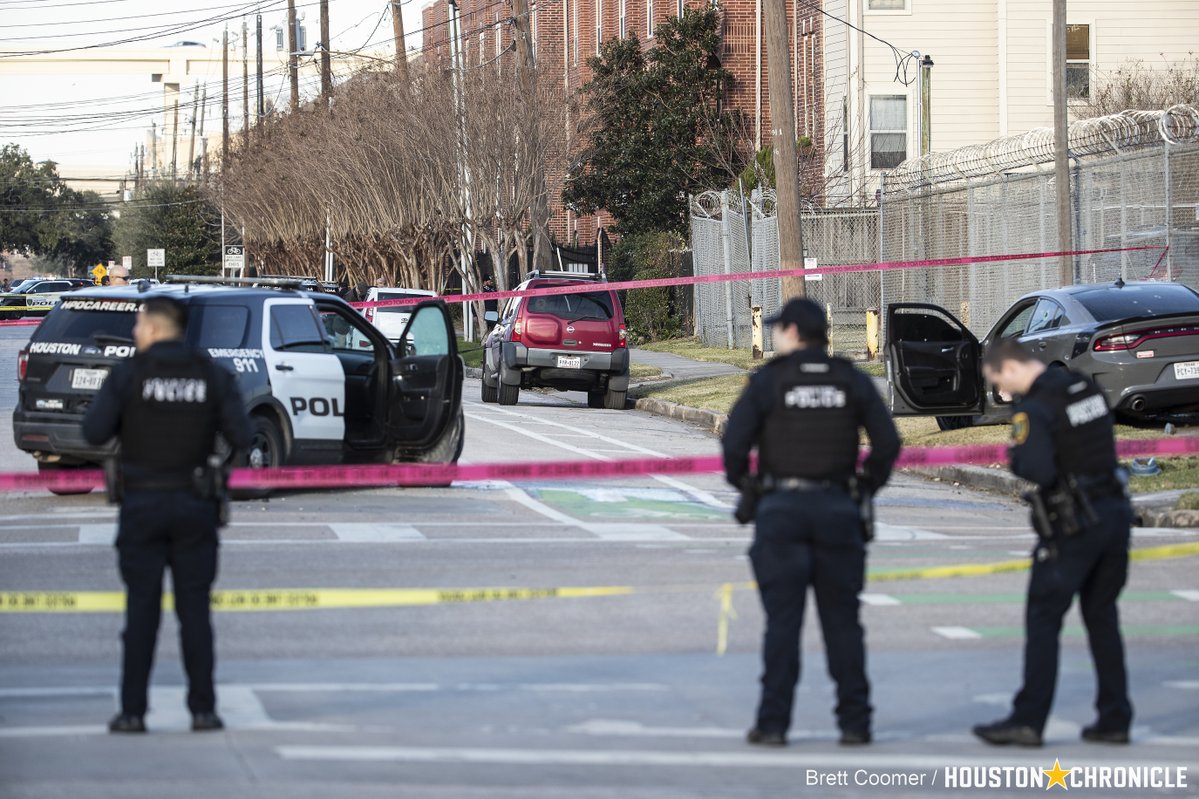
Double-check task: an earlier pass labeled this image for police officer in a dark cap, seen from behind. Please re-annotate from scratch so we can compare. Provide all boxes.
[723,300,900,746]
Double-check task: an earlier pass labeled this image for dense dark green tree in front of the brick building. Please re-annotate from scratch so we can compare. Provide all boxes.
[562,8,740,234]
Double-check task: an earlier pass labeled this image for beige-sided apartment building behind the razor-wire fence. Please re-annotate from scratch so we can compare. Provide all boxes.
[823,0,1199,205]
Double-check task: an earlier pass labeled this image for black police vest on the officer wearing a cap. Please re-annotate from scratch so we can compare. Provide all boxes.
[758,356,858,480]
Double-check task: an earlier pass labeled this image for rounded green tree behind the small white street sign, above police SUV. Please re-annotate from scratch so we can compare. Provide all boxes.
[113,182,221,277]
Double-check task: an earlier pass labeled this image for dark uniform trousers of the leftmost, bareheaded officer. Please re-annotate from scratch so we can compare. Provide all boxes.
[116,491,217,716]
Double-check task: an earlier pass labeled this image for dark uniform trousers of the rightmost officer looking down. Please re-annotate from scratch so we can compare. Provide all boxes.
[1011,498,1132,731]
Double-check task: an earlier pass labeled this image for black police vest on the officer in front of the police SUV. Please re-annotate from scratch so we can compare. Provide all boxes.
[121,344,221,477]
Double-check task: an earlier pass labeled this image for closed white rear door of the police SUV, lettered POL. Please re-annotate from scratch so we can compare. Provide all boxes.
[263,298,345,441]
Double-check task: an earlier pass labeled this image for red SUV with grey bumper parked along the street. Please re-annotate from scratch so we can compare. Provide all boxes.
[483,272,628,410]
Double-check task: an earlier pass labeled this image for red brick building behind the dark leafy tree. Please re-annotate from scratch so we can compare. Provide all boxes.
[422,0,825,246]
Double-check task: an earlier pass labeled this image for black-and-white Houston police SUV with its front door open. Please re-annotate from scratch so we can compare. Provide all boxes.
[13,281,464,484]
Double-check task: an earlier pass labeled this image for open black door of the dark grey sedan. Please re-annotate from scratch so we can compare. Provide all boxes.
[886,302,983,416]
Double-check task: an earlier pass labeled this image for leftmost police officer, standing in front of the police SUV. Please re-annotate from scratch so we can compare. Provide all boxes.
[83,296,253,733]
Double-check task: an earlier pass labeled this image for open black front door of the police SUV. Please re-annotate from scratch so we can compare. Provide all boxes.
[387,300,463,450]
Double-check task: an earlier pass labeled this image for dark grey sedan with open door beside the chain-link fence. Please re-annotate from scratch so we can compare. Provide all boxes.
[886,281,1199,429]
